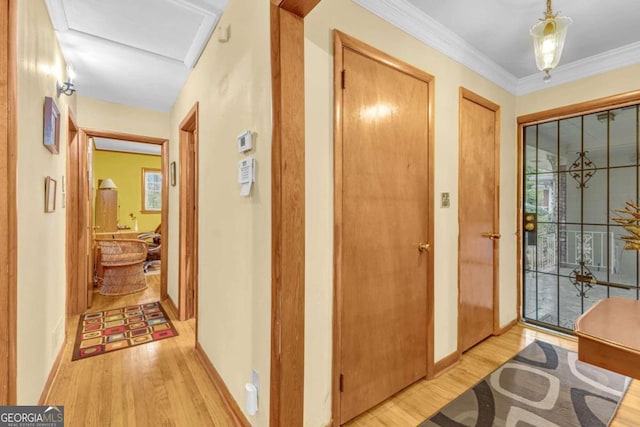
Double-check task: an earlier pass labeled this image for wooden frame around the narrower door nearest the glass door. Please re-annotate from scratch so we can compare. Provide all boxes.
[457,87,500,358]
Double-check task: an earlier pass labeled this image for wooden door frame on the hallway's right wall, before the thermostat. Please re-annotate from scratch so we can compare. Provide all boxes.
[178,102,199,320]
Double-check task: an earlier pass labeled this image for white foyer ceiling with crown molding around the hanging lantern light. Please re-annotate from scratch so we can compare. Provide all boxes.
[353,0,640,95]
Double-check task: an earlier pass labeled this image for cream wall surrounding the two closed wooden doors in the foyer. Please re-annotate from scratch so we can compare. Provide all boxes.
[304,0,517,426]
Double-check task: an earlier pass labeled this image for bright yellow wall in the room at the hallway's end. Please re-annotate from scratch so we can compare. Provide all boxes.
[93,150,162,232]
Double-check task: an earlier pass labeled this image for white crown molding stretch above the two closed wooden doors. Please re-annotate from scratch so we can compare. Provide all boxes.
[353,0,518,94]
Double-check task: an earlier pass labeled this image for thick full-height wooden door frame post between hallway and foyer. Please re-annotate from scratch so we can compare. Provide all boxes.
[268,0,320,427]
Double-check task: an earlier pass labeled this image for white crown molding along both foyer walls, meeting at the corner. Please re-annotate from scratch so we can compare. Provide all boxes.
[352,0,640,96]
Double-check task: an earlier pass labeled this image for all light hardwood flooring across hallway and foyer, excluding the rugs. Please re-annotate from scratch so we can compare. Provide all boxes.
[45,276,640,427]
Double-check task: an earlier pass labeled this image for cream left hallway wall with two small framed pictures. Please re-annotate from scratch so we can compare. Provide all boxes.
[17,0,76,405]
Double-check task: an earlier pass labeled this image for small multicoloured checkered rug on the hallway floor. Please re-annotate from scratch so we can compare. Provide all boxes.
[71,301,178,361]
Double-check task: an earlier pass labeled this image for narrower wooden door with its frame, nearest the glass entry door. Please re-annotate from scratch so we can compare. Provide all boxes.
[458,89,500,352]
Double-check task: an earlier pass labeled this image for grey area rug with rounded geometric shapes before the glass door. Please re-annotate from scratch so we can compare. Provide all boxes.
[419,341,631,427]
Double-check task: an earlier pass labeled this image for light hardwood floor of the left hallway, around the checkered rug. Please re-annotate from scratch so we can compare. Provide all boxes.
[43,275,234,427]
